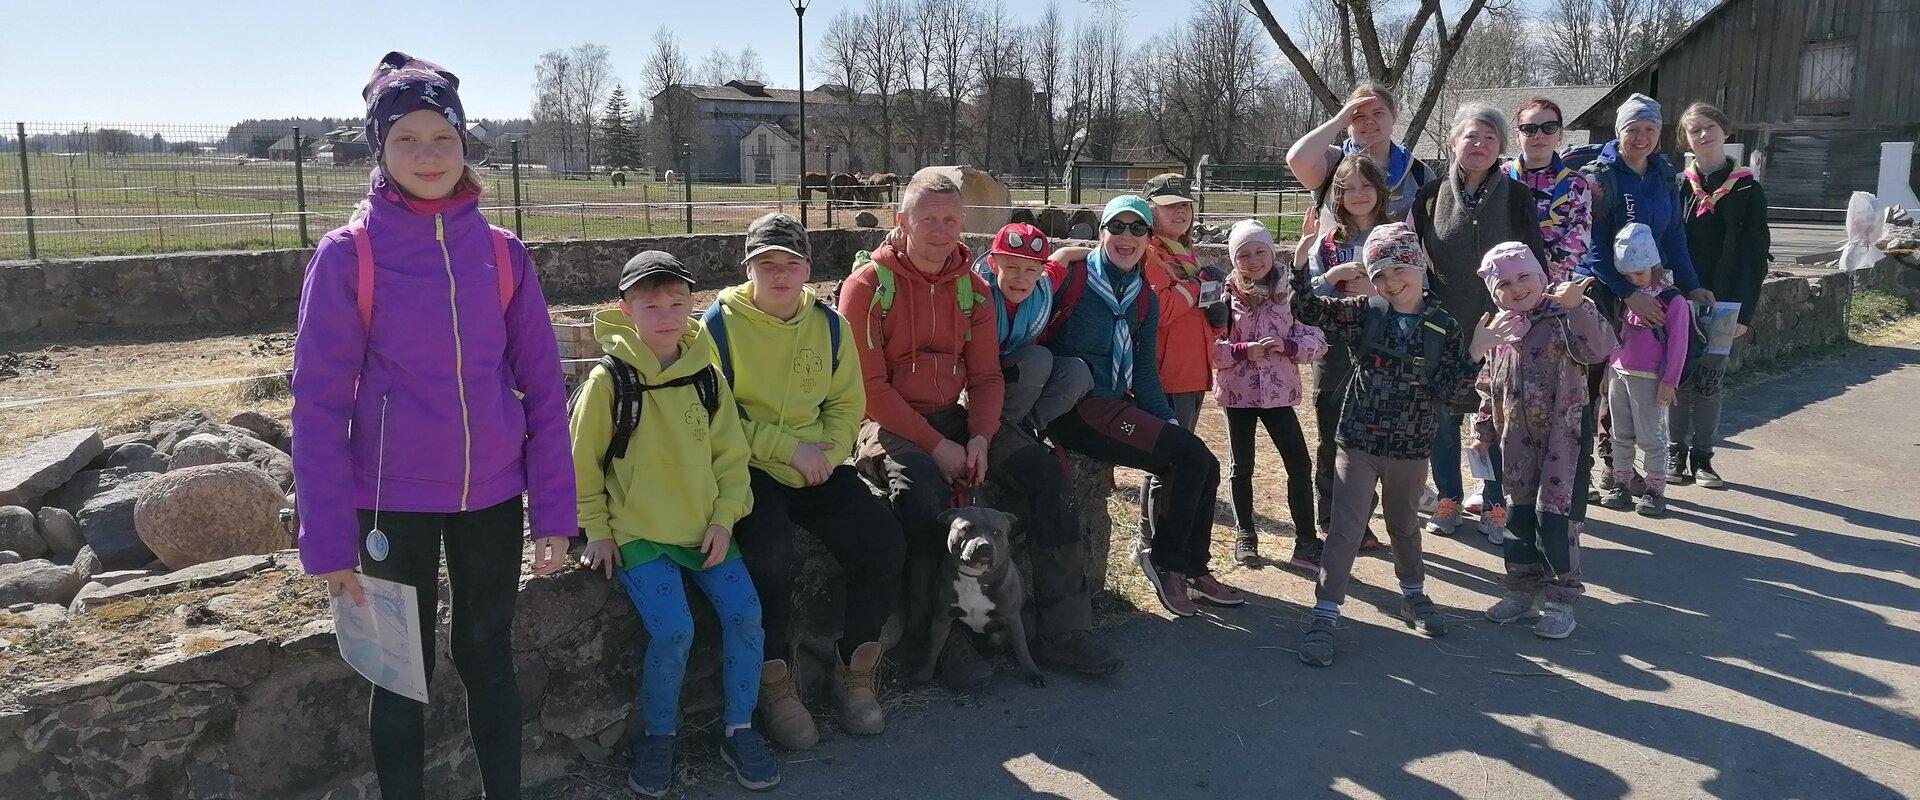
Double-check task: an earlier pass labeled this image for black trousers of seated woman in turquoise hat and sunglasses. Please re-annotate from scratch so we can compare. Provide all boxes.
[1046,403,1219,577]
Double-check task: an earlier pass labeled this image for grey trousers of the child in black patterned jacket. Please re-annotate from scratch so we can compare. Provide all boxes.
[1313,447,1427,604]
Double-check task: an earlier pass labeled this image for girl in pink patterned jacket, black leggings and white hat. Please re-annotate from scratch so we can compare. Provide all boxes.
[1212,219,1327,568]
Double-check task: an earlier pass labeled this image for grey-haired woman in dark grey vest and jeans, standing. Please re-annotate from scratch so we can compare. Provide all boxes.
[1413,104,1546,543]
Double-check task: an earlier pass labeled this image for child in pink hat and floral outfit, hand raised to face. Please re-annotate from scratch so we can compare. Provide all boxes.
[1473,242,1617,639]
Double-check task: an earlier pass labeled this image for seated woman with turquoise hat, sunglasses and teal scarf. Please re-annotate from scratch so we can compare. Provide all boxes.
[1044,194,1246,616]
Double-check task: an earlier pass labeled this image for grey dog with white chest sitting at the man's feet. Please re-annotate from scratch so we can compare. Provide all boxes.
[914,506,1046,687]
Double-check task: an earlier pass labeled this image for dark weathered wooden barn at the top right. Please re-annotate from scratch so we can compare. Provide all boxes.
[1572,0,1920,209]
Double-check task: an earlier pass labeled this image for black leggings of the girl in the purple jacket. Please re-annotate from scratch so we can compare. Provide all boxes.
[359,497,526,800]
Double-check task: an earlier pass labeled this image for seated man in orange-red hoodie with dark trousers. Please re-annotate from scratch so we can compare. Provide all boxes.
[839,171,1119,691]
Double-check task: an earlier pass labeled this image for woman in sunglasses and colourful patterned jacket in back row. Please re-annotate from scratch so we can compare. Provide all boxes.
[1501,98,1594,284]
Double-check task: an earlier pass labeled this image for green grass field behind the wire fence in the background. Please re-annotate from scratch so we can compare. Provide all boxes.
[0,153,1306,259]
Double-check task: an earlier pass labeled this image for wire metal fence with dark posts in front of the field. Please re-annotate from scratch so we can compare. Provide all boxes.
[0,121,1308,259]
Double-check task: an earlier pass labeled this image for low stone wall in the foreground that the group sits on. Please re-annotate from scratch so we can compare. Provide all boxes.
[0,457,1112,800]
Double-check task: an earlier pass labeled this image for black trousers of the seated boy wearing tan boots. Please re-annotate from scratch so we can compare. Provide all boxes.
[733,464,906,660]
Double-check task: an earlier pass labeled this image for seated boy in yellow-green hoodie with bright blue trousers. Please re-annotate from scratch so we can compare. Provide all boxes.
[570,249,780,796]
